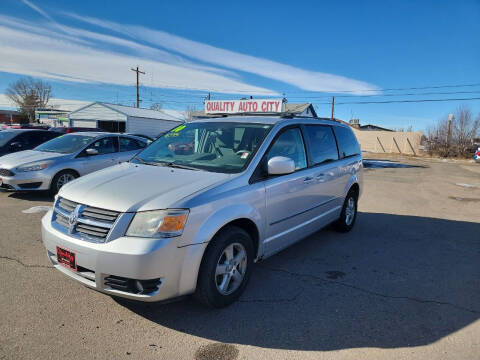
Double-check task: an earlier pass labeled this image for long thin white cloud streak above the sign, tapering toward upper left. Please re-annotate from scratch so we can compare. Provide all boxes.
[63,13,380,95]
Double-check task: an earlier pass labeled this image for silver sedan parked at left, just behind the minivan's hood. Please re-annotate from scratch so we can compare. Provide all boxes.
[0,132,147,194]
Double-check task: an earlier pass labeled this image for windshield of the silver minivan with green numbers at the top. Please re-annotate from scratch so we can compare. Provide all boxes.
[133,122,271,173]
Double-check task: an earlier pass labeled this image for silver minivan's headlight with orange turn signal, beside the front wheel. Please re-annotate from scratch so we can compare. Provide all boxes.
[126,209,189,238]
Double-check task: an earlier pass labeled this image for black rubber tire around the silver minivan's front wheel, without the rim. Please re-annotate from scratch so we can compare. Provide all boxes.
[195,226,255,308]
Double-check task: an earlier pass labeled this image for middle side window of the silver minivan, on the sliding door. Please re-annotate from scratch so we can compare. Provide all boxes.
[305,125,338,165]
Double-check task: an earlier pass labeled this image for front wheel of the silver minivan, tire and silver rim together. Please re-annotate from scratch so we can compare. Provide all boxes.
[195,226,254,308]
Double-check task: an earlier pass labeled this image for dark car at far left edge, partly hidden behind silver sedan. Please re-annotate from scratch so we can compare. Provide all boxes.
[0,129,61,156]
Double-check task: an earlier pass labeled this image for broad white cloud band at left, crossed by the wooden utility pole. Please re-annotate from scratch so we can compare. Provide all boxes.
[0,21,275,95]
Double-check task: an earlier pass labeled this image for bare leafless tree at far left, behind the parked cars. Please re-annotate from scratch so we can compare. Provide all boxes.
[6,77,52,122]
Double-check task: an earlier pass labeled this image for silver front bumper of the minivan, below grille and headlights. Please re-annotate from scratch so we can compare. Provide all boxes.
[42,211,206,302]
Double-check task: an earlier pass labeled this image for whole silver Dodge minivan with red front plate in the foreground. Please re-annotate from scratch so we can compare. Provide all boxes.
[42,117,362,307]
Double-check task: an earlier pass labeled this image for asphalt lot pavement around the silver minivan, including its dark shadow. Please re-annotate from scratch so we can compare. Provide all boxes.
[0,155,480,360]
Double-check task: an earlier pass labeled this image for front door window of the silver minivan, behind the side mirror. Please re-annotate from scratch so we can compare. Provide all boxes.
[267,128,307,170]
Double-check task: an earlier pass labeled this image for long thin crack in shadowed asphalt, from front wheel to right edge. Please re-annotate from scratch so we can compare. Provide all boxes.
[259,266,480,314]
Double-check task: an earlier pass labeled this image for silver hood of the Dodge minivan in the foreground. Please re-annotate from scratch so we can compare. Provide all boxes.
[59,163,231,212]
